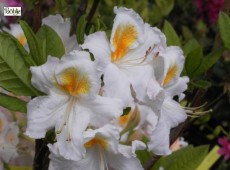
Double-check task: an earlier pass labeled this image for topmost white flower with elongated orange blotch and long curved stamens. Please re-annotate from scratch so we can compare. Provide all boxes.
[81,7,166,105]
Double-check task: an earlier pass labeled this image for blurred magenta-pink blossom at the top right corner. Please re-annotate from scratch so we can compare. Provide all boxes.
[195,0,224,24]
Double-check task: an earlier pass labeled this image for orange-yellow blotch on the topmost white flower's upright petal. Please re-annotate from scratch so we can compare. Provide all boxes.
[111,24,138,62]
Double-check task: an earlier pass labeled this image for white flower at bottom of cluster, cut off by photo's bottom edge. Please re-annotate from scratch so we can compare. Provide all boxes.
[49,125,143,170]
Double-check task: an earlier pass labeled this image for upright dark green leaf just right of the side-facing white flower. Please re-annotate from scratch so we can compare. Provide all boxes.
[185,47,203,78]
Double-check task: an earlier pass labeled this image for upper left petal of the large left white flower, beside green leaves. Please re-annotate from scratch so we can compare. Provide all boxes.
[30,56,59,94]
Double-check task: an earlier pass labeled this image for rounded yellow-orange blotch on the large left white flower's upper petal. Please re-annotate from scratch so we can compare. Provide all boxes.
[58,67,91,96]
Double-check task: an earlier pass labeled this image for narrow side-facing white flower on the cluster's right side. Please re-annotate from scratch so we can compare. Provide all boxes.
[148,47,189,155]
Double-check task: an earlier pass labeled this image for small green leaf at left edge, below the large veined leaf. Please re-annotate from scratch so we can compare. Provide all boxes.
[0,93,27,113]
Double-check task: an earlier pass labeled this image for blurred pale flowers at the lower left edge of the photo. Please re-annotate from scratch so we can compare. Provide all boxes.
[0,111,19,169]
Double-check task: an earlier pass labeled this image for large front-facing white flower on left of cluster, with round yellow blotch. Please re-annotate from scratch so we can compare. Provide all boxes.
[26,51,123,160]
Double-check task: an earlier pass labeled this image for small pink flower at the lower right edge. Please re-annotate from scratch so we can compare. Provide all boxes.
[218,137,230,160]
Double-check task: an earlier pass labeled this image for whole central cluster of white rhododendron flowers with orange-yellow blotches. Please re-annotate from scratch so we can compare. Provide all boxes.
[26,7,189,170]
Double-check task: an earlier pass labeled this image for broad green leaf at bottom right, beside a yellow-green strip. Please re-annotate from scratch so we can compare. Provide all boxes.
[152,146,208,170]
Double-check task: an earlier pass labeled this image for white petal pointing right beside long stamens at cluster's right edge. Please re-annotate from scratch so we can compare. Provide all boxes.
[161,97,187,128]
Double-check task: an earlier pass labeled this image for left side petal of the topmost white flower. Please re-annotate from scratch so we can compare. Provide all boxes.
[81,32,111,71]
